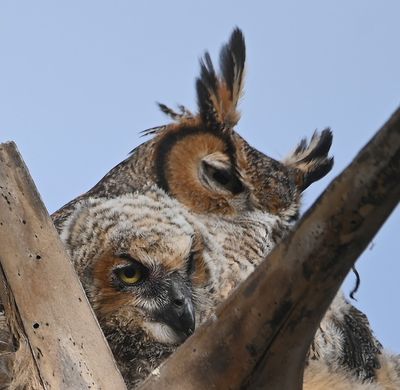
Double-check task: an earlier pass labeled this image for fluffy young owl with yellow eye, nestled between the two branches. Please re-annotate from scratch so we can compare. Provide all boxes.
[0,186,216,389]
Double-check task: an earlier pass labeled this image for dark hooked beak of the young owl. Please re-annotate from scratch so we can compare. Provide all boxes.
[159,279,196,341]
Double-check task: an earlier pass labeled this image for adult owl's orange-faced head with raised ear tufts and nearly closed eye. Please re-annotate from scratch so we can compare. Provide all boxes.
[147,29,333,220]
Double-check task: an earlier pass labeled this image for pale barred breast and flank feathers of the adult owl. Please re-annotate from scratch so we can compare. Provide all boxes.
[196,204,388,389]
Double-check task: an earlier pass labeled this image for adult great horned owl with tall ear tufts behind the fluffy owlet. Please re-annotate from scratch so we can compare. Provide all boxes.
[48,29,392,386]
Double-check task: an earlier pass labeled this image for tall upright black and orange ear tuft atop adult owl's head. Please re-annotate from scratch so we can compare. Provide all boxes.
[196,28,246,130]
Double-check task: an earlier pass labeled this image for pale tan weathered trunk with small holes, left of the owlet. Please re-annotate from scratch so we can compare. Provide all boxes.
[0,143,126,389]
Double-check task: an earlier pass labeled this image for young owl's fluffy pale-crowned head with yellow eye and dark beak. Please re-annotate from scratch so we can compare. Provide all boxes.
[61,190,209,344]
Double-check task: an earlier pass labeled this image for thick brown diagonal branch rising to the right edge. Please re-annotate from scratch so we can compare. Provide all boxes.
[140,106,400,390]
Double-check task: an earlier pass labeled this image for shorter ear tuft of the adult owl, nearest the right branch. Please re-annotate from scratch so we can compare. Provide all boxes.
[283,129,333,191]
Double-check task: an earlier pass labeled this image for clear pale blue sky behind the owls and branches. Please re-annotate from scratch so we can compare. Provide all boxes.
[0,0,400,352]
